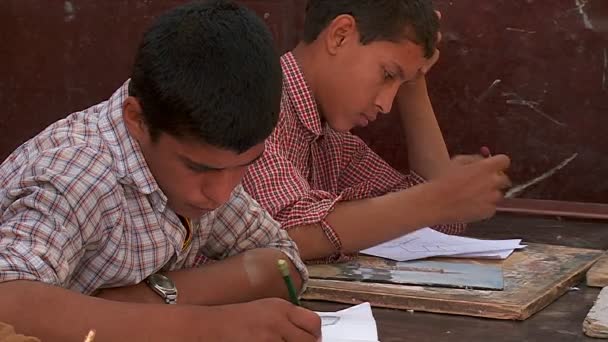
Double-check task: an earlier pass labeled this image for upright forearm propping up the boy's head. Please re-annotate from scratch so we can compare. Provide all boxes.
[397,77,450,180]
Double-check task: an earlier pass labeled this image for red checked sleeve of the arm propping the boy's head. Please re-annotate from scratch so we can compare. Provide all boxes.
[339,134,466,234]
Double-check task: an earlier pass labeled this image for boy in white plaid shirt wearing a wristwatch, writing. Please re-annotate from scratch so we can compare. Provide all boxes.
[0,1,320,341]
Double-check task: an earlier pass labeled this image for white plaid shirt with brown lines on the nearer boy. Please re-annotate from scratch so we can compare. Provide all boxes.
[0,83,307,294]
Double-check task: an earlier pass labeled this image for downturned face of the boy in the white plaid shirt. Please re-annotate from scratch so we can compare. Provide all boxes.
[125,98,264,219]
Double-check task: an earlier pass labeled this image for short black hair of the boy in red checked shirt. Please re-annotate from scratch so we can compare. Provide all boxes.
[303,0,439,58]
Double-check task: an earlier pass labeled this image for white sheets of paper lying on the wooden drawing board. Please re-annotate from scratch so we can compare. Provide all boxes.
[361,228,526,261]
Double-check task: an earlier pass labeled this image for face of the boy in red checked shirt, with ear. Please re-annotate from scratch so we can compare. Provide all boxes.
[315,19,428,131]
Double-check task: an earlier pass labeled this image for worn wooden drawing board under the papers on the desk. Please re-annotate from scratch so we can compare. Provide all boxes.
[303,244,603,320]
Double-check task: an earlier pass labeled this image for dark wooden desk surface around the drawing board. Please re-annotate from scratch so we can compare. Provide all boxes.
[305,214,608,342]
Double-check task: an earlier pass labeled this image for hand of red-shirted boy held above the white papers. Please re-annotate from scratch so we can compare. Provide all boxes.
[429,155,511,223]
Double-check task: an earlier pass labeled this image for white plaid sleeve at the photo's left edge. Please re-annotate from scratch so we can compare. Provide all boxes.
[0,149,116,287]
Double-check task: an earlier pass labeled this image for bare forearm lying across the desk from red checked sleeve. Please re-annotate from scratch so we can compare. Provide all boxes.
[288,184,443,260]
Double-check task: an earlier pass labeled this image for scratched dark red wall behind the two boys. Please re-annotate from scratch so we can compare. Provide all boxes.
[0,0,608,203]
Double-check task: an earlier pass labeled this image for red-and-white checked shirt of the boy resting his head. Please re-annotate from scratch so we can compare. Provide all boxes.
[243,52,464,259]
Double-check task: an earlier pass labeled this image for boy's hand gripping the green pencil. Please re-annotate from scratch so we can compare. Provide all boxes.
[203,298,321,342]
